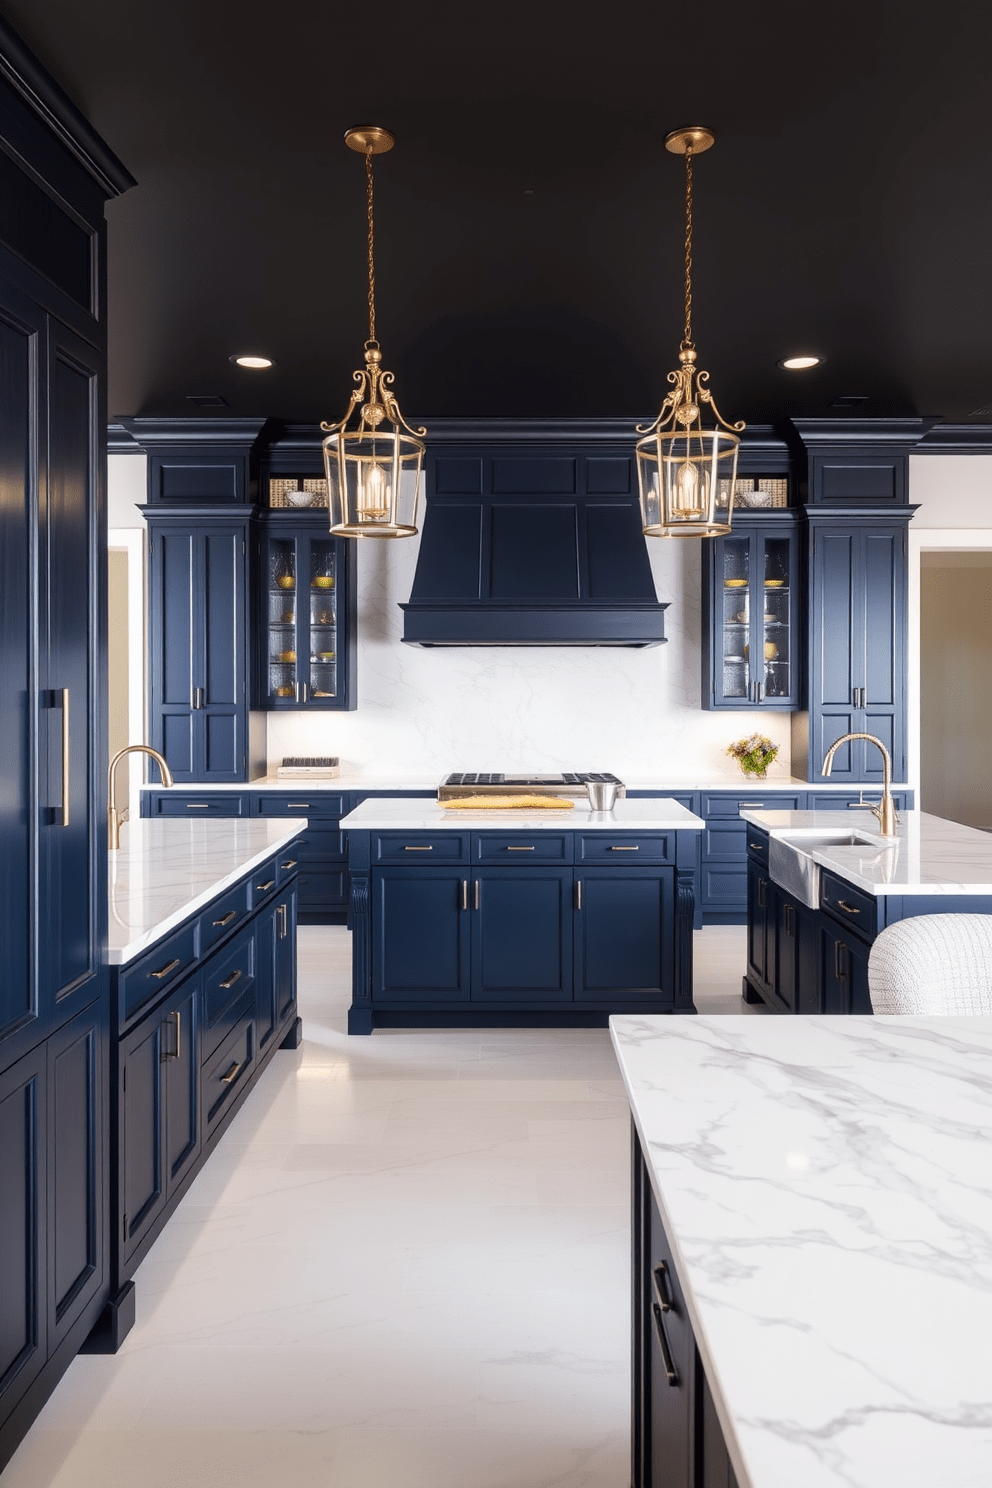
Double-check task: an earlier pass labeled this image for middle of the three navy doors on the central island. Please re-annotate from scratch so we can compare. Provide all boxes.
[471,869,571,1001]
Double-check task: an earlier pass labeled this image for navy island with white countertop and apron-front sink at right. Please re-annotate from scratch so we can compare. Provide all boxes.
[741,808,992,1013]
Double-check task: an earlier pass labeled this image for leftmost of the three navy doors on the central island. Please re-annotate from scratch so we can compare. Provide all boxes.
[372,868,470,1001]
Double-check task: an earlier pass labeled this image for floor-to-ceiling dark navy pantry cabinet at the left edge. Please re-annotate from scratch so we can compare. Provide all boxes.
[0,21,134,1469]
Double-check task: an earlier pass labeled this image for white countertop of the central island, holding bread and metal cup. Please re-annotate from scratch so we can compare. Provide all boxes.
[341,796,705,832]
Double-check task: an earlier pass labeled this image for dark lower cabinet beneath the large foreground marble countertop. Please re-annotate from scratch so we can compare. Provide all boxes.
[631,1135,738,1488]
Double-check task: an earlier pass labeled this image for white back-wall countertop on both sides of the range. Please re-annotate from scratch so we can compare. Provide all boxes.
[141,765,910,796]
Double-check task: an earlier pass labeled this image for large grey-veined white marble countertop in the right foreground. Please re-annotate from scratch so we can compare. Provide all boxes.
[610,1016,992,1488]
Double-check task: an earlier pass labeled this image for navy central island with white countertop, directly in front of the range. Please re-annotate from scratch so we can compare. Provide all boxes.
[341,798,703,1034]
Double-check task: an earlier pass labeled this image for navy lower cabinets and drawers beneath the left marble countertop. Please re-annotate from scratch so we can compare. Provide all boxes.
[104,847,299,1353]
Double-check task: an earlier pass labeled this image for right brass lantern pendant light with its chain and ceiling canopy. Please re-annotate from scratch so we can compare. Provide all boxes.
[637,128,745,537]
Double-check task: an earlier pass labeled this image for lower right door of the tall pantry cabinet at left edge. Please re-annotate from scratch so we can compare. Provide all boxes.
[48,1006,107,1353]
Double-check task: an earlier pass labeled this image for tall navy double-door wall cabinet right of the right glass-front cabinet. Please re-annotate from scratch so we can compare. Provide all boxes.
[793,507,912,783]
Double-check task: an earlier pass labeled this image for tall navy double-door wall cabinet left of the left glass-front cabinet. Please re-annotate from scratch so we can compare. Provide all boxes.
[149,509,250,783]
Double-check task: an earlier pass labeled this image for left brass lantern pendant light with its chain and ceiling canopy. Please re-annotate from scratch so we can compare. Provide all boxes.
[320,124,427,537]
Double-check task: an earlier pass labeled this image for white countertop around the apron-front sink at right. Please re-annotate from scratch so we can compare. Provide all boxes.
[741,806,992,896]
